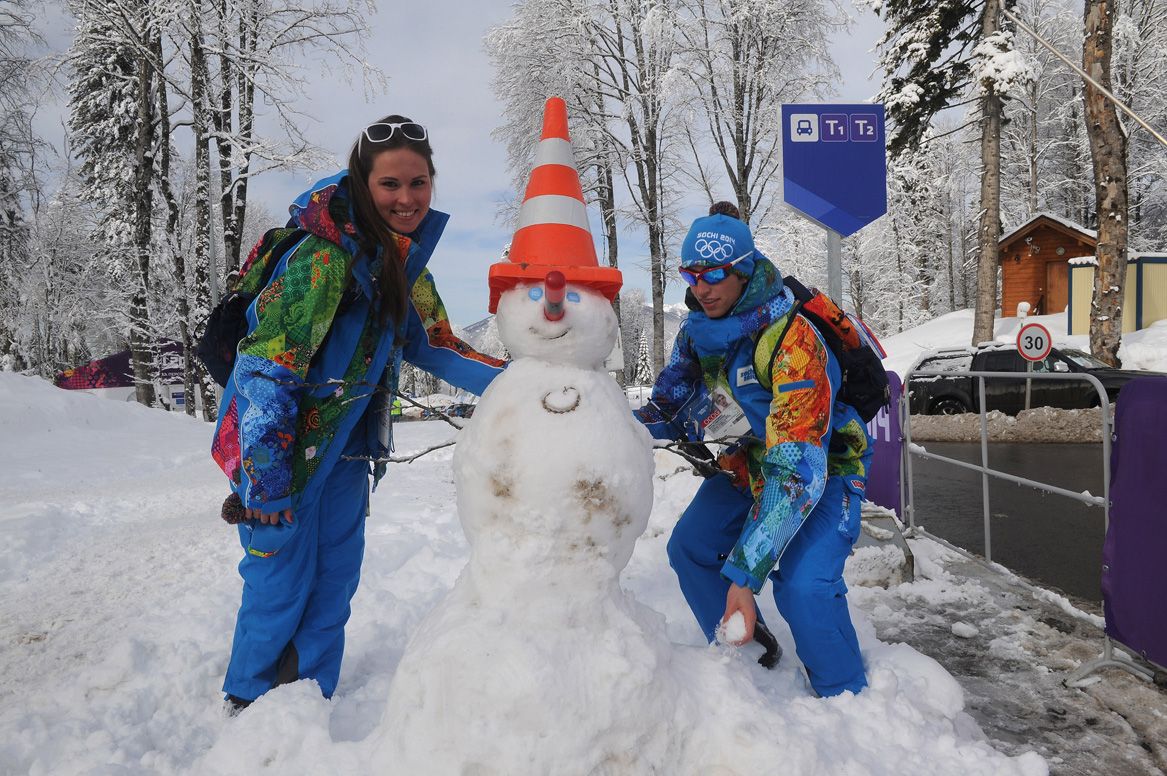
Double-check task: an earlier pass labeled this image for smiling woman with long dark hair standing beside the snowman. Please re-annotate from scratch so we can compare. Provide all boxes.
[212,116,503,709]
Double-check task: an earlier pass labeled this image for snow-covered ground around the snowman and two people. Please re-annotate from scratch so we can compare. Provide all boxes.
[0,373,1167,776]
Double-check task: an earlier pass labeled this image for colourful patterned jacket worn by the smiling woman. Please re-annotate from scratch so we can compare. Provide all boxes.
[211,172,503,512]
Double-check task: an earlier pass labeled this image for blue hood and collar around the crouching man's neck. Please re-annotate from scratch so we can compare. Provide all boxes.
[686,253,795,355]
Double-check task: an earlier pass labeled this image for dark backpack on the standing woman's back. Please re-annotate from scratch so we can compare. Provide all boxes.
[197,226,308,387]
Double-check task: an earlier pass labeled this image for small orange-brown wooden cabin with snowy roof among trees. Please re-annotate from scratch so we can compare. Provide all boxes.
[997,212,1098,317]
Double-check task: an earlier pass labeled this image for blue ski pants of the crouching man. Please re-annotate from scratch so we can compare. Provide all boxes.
[669,477,867,697]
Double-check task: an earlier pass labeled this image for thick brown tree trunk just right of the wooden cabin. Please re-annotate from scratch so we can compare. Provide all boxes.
[1082,0,1127,366]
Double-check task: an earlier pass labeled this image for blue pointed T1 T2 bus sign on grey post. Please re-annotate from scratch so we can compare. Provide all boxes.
[782,104,887,301]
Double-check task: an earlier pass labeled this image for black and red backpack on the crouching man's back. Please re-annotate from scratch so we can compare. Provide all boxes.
[766,275,892,422]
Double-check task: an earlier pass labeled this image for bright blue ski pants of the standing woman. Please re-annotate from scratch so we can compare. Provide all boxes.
[223,450,369,700]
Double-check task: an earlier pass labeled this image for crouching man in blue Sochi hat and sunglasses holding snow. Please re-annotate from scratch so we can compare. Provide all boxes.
[638,203,872,697]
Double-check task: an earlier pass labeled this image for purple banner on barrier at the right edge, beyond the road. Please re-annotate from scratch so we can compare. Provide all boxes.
[1102,377,1167,665]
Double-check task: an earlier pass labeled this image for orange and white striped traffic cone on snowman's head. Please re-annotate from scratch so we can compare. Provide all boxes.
[489,97,623,313]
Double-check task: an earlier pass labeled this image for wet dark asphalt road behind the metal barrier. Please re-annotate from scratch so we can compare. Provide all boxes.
[911,442,1104,602]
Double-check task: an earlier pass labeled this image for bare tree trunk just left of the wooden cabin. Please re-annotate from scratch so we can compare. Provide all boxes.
[972,0,1001,345]
